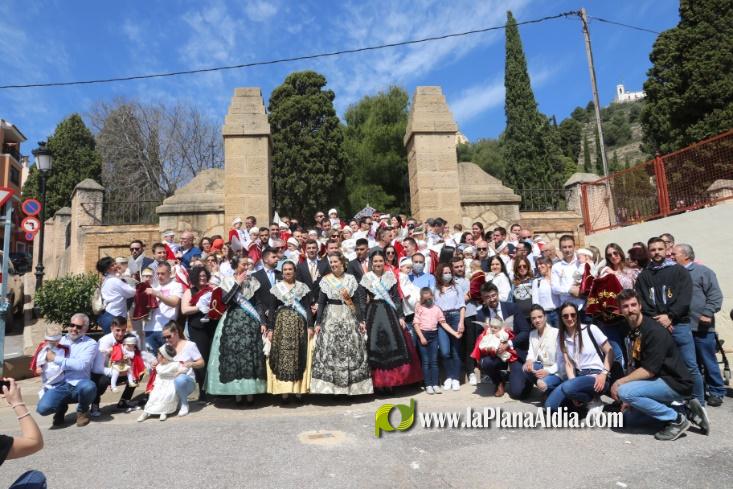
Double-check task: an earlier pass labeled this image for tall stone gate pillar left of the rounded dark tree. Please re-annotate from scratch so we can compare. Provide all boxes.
[221,88,272,229]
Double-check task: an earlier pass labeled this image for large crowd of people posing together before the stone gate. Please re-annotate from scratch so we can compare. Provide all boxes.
[34,209,726,440]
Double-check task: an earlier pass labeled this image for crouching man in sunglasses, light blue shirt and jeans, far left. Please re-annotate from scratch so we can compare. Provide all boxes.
[36,313,97,428]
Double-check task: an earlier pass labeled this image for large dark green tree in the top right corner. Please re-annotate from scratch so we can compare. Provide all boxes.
[641,0,733,154]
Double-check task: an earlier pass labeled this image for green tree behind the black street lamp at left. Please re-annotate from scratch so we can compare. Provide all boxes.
[23,114,102,217]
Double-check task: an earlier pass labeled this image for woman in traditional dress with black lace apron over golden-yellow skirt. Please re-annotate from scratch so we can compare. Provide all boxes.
[267,260,313,402]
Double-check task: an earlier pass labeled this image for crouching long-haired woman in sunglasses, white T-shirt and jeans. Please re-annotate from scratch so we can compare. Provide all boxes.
[545,302,613,420]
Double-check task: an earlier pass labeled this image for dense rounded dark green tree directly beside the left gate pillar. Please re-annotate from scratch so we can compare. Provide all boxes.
[268,71,347,219]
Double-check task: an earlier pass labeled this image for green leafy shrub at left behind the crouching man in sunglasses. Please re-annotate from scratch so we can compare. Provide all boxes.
[35,273,99,326]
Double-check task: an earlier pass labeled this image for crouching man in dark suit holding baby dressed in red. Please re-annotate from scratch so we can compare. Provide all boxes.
[476,283,532,399]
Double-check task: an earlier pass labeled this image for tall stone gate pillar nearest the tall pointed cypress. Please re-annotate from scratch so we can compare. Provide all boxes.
[404,87,461,224]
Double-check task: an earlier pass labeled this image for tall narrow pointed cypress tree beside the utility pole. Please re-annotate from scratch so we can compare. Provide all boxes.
[504,12,566,194]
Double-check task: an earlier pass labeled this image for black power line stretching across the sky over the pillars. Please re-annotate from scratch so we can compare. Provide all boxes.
[0,11,658,90]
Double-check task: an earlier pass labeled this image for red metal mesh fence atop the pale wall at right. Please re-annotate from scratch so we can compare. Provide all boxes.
[580,129,733,234]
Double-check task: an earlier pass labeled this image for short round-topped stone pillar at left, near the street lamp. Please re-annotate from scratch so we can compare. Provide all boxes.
[69,178,104,273]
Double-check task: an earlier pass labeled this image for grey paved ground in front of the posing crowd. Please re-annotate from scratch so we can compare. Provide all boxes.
[0,380,733,489]
